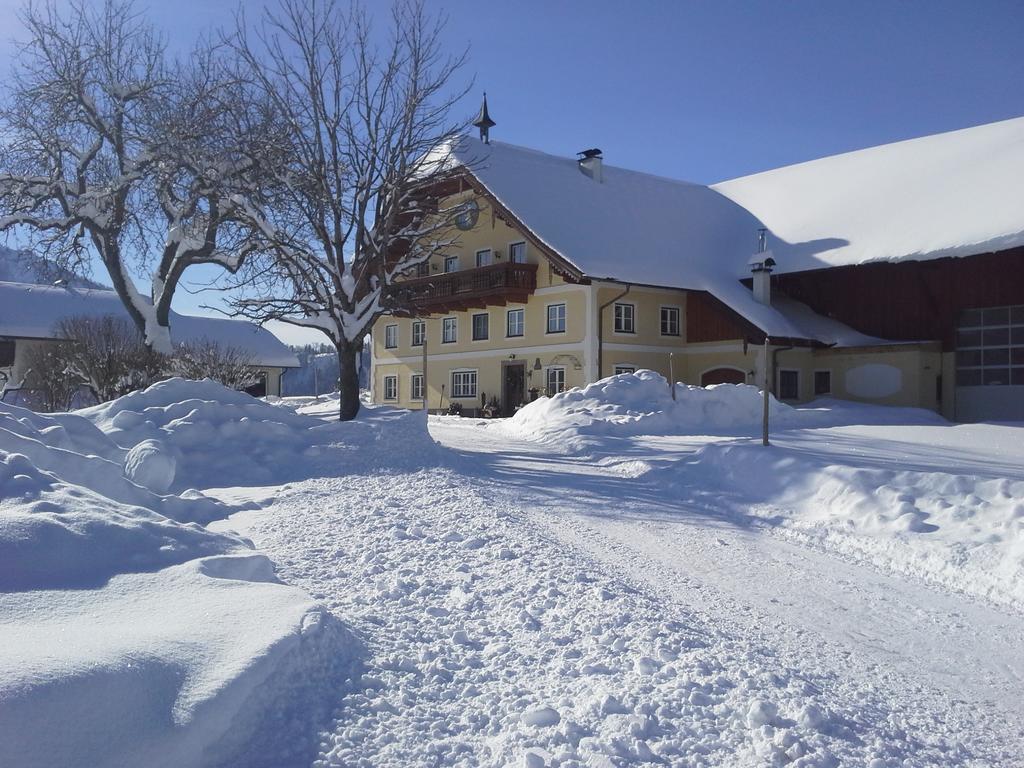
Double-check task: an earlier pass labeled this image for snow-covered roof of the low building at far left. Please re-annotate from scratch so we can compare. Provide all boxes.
[0,283,299,368]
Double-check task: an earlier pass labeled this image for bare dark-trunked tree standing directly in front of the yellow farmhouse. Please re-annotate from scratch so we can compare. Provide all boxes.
[229,0,465,420]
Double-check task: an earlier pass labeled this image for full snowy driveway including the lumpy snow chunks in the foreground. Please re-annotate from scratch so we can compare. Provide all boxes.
[218,418,1024,768]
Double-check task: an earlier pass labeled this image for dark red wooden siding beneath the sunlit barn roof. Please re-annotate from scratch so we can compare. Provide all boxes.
[774,248,1024,349]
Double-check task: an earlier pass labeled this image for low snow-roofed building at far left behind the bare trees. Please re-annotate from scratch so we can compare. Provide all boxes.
[0,282,299,403]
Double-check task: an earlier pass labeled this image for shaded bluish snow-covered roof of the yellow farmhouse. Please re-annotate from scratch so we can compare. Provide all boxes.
[454,137,805,338]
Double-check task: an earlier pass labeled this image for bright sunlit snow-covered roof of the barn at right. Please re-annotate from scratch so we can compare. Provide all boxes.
[711,112,1024,272]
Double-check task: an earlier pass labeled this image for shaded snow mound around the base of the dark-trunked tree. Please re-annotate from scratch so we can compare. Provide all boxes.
[77,379,435,490]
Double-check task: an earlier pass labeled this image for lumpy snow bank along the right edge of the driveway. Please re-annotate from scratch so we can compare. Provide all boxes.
[649,438,1024,606]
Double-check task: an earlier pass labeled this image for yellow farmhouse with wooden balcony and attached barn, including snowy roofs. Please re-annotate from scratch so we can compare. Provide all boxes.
[372,112,1024,421]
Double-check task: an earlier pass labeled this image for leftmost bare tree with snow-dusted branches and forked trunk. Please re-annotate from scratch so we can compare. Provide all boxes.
[0,0,261,353]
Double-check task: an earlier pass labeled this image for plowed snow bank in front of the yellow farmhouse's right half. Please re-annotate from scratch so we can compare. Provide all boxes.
[504,370,941,453]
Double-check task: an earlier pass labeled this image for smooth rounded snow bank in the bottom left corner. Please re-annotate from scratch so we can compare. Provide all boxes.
[0,555,359,768]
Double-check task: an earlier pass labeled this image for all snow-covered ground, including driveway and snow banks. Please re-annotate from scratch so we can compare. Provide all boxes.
[0,373,1024,768]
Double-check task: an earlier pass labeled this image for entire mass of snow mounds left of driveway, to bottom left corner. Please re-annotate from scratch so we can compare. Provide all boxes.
[0,381,368,767]
